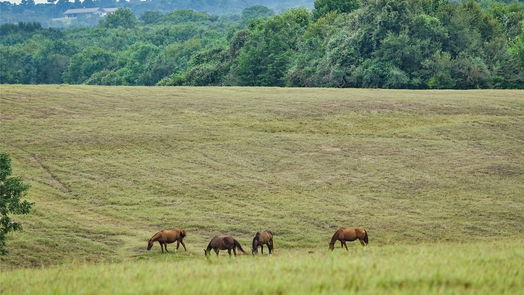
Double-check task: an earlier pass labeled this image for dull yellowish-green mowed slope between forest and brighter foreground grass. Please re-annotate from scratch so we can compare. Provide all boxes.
[0,85,524,269]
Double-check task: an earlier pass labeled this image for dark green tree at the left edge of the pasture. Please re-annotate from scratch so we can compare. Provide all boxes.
[0,153,33,255]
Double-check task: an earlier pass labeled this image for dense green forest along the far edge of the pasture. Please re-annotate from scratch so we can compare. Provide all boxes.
[0,0,524,89]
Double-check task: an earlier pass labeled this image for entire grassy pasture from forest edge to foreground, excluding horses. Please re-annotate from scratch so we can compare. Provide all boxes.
[0,85,524,294]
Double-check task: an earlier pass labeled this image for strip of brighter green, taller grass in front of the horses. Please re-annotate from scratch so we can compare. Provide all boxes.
[0,240,524,294]
